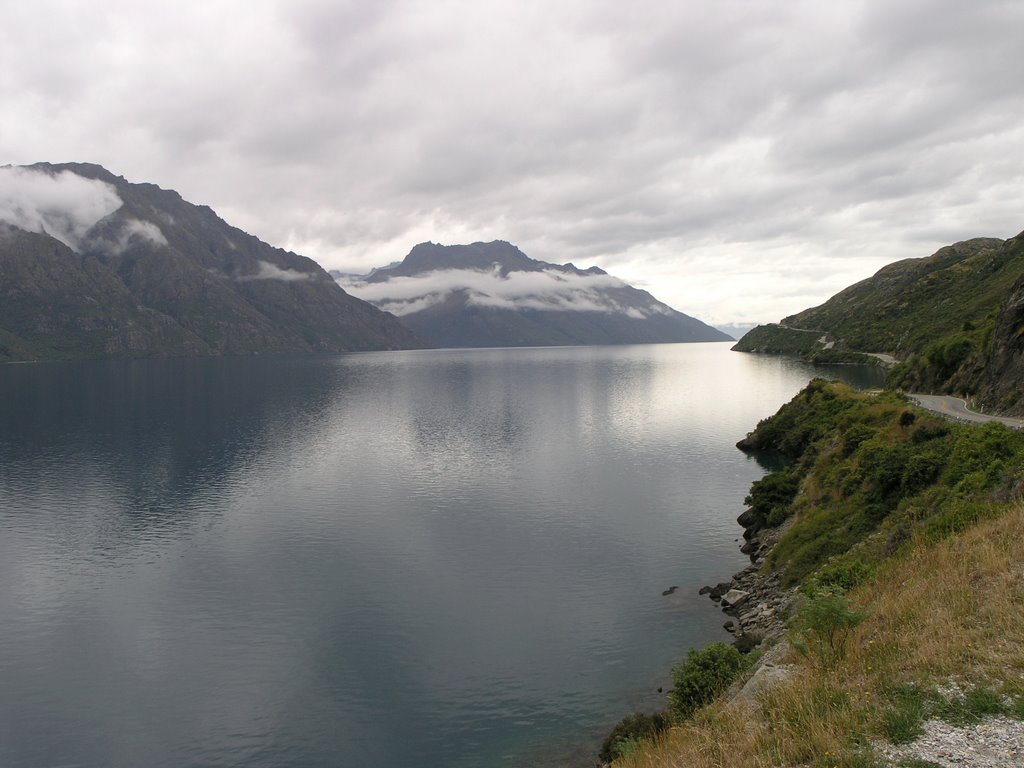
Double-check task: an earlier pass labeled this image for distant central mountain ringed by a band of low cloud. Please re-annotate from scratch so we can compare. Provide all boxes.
[339,241,731,347]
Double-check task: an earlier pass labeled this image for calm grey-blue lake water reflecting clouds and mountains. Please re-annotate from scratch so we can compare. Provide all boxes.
[0,344,878,768]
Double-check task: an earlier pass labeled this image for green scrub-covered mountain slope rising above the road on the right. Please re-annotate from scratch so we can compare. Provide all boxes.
[733,232,1024,413]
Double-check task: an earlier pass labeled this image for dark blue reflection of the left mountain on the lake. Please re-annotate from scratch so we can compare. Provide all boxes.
[0,358,345,539]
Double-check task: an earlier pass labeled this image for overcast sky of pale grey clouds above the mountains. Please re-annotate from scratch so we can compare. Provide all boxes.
[0,0,1024,324]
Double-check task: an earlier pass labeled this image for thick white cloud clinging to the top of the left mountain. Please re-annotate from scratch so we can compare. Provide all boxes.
[0,167,121,252]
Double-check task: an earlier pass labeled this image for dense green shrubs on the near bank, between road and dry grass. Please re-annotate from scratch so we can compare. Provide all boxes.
[750,380,1024,588]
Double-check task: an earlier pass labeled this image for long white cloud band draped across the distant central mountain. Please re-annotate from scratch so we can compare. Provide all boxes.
[338,265,671,319]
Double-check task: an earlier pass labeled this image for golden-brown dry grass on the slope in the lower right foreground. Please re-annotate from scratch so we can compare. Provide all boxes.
[621,505,1024,768]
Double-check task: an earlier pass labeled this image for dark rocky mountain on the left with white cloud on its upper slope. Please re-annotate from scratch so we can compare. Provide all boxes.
[0,163,426,360]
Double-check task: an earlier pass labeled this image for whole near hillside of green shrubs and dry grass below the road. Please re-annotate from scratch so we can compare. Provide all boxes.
[598,380,1024,768]
